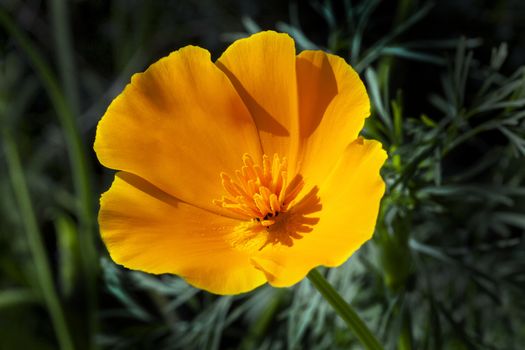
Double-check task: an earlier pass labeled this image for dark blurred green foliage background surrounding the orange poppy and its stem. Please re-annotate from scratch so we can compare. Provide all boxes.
[0,0,525,349]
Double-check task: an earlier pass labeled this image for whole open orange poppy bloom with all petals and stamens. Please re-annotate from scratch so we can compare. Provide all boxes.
[95,32,386,294]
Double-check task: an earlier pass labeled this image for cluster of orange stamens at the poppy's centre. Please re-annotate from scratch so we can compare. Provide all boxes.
[213,154,304,227]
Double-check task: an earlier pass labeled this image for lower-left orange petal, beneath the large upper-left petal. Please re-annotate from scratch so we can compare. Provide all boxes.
[99,172,266,294]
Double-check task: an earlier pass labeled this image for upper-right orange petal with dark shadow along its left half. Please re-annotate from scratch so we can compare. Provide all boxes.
[297,51,370,189]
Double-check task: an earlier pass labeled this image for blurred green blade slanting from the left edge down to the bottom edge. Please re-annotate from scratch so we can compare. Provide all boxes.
[2,131,73,350]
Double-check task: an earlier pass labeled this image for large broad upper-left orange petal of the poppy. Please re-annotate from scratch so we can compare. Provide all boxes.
[95,46,261,215]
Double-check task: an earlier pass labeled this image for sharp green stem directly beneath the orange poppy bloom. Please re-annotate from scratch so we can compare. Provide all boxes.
[308,270,383,350]
